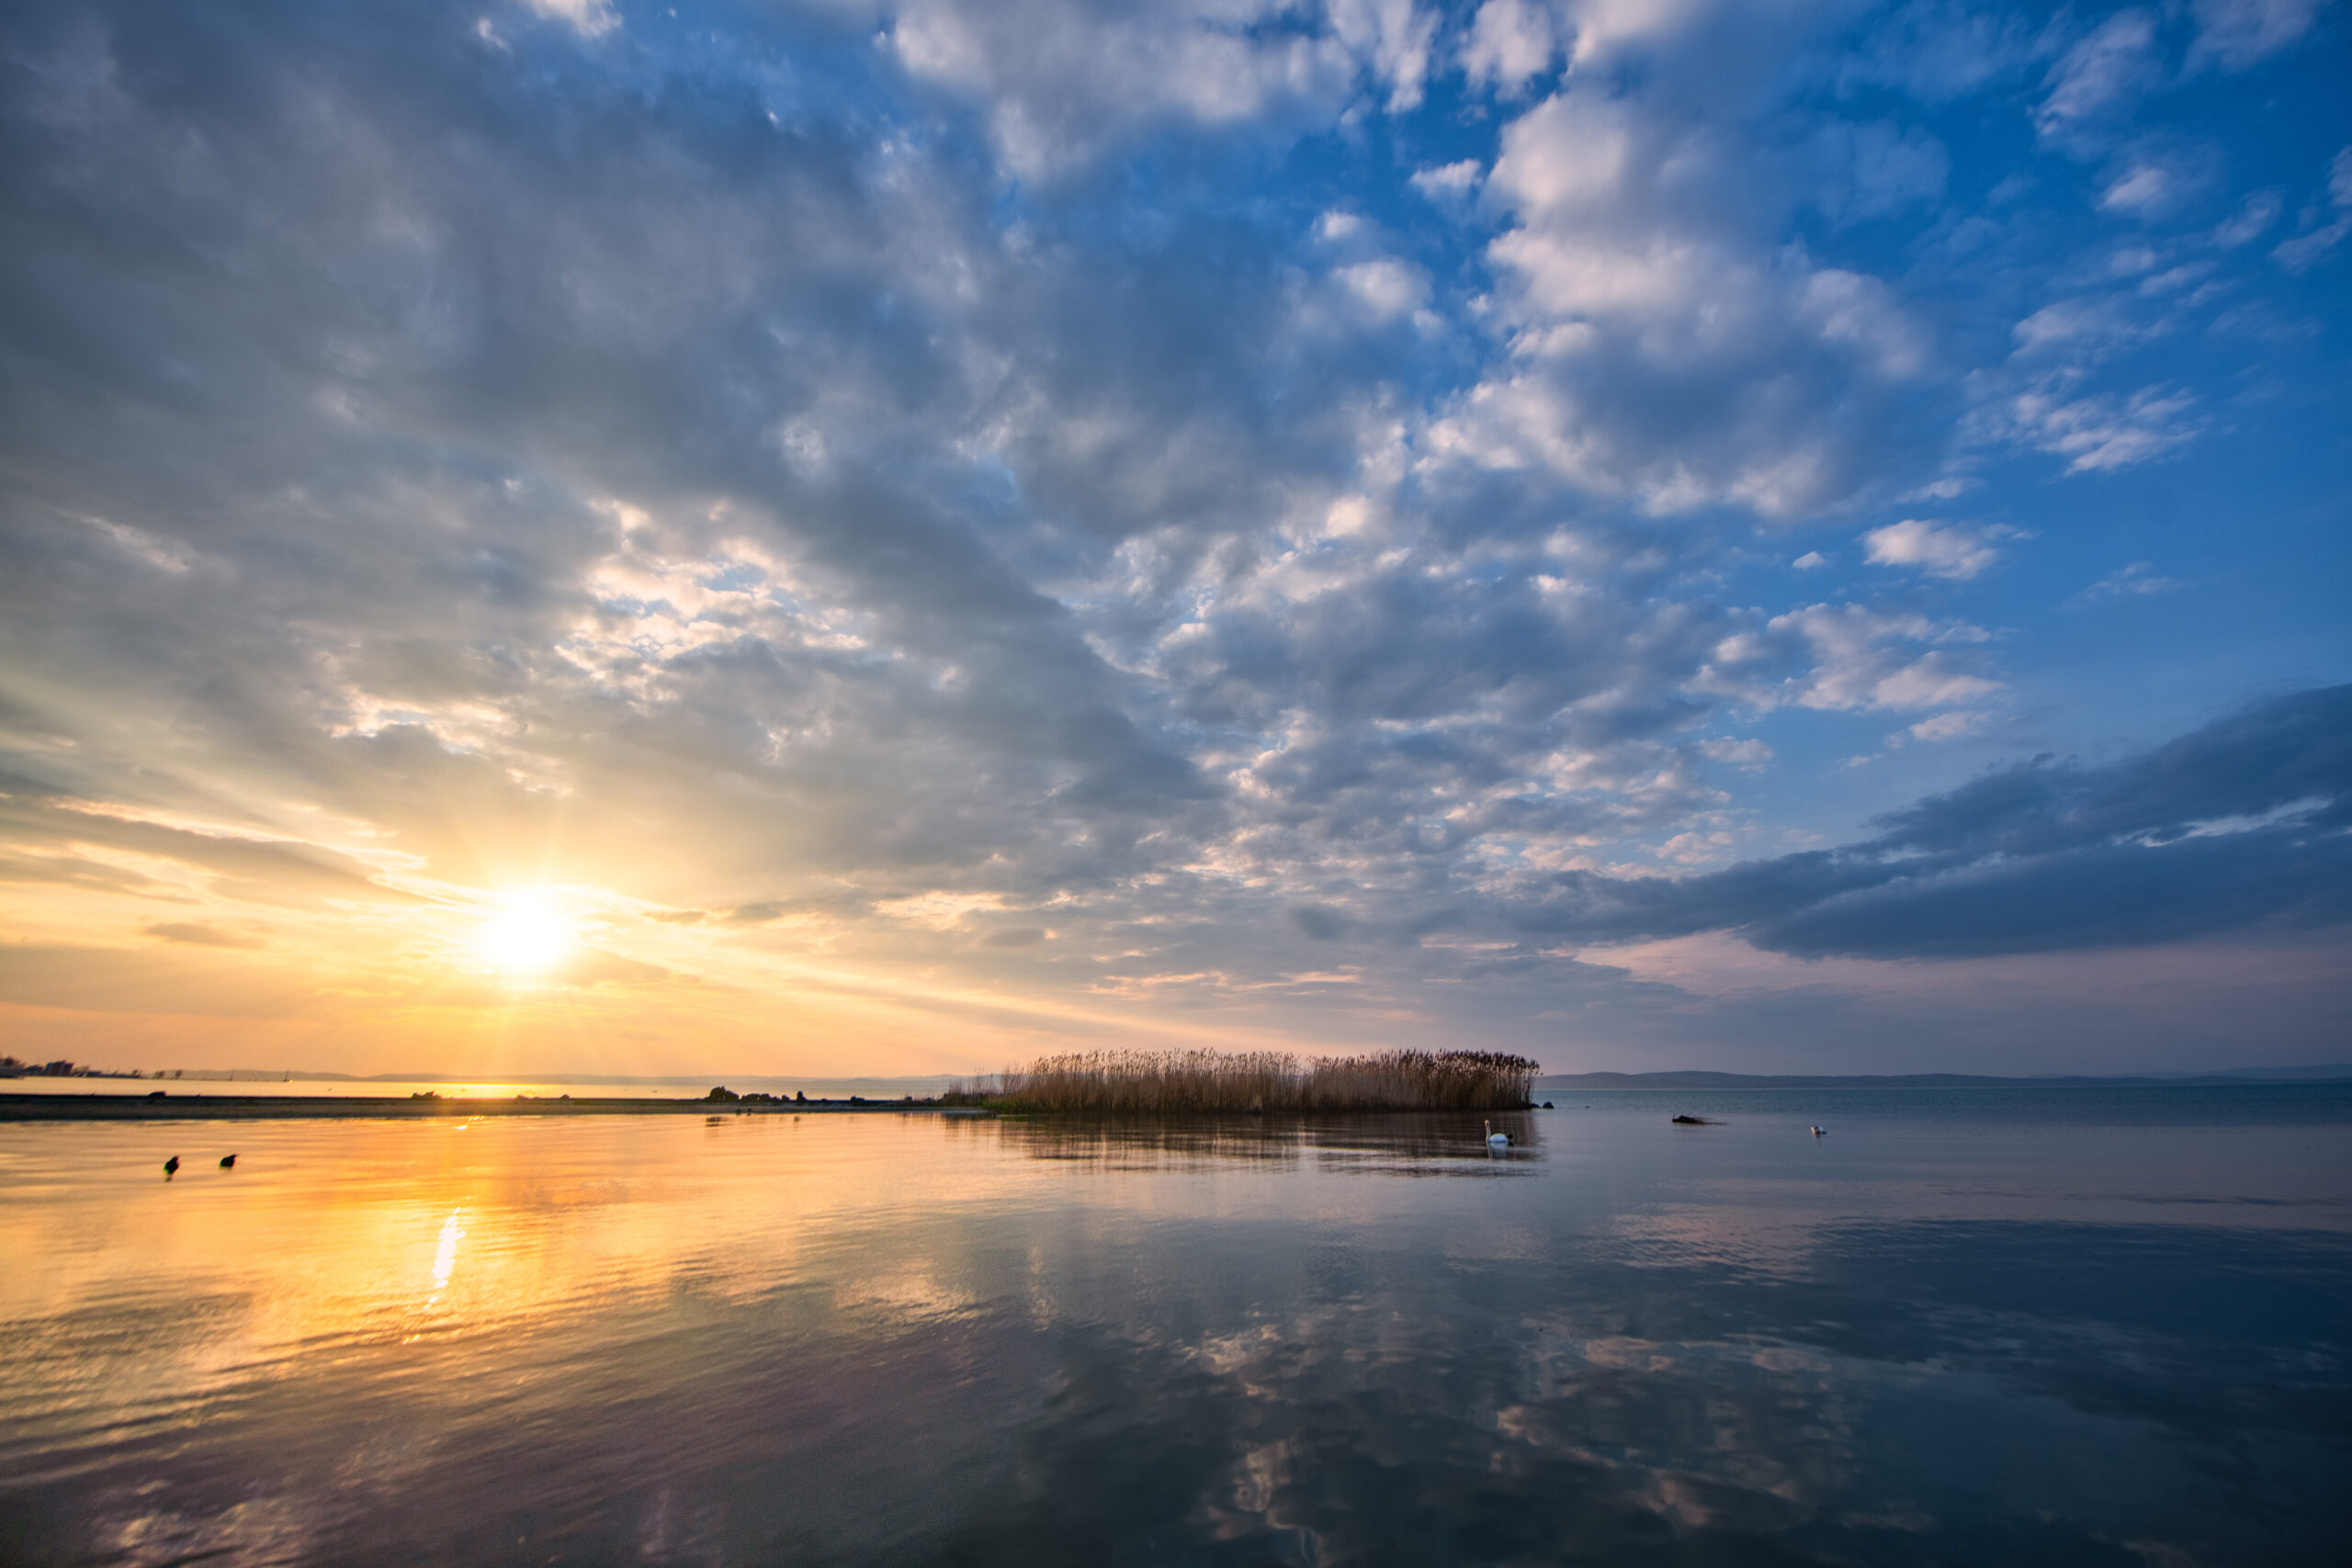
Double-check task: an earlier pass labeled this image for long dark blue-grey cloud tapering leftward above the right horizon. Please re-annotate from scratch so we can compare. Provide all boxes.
[1517,686,2352,957]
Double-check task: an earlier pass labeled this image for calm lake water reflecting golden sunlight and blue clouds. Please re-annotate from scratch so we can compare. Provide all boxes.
[0,1086,2352,1568]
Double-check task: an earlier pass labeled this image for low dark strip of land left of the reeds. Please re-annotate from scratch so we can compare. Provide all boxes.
[0,1090,988,1123]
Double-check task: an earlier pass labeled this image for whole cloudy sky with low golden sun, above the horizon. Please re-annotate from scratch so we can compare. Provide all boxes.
[0,0,2352,1075]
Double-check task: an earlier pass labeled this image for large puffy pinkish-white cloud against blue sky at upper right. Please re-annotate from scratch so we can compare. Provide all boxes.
[1423,87,1931,517]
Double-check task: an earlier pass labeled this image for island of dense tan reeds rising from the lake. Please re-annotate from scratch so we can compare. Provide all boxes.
[941,1051,1543,1117]
